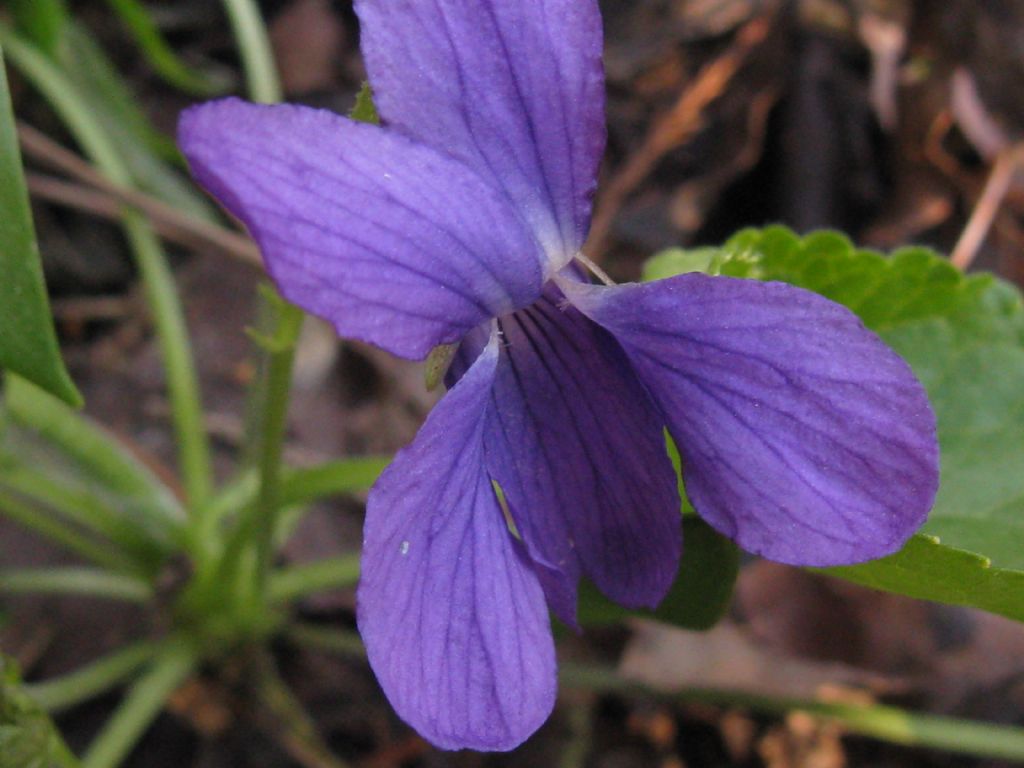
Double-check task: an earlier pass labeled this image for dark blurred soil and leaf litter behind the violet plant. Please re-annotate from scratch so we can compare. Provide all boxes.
[0,0,1024,768]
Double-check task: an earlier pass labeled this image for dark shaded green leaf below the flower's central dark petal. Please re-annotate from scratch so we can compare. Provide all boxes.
[577,515,739,630]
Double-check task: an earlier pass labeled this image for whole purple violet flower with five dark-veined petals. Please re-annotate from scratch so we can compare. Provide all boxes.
[179,0,938,750]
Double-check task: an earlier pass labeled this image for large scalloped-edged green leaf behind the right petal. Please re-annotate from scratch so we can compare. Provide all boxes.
[646,227,1024,621]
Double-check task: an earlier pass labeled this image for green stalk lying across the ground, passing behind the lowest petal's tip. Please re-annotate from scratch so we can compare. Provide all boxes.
[288,624,1024,761]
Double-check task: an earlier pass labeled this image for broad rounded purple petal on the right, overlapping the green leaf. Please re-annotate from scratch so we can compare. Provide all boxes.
[566,274,938,566]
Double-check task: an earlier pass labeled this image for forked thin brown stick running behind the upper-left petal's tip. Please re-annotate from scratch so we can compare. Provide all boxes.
[17,123,262,265]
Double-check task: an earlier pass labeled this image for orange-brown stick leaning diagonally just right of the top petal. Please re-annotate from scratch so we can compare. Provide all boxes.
[584,16,771,261]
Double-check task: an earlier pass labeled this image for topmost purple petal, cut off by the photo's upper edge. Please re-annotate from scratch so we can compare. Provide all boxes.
[355,0,604,268]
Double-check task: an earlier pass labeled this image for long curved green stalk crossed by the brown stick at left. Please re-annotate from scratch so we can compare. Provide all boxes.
[0,25,212,509]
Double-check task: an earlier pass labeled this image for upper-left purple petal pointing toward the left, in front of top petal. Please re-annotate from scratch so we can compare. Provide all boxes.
[178,99,544,357]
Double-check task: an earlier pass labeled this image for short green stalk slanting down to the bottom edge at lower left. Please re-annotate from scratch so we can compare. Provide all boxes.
[82,638,199,768]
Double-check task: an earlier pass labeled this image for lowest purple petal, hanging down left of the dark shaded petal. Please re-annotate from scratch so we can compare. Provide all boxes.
[357,335,556,750]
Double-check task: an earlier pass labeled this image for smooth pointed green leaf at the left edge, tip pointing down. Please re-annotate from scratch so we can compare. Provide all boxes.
[0,44,82,408]
